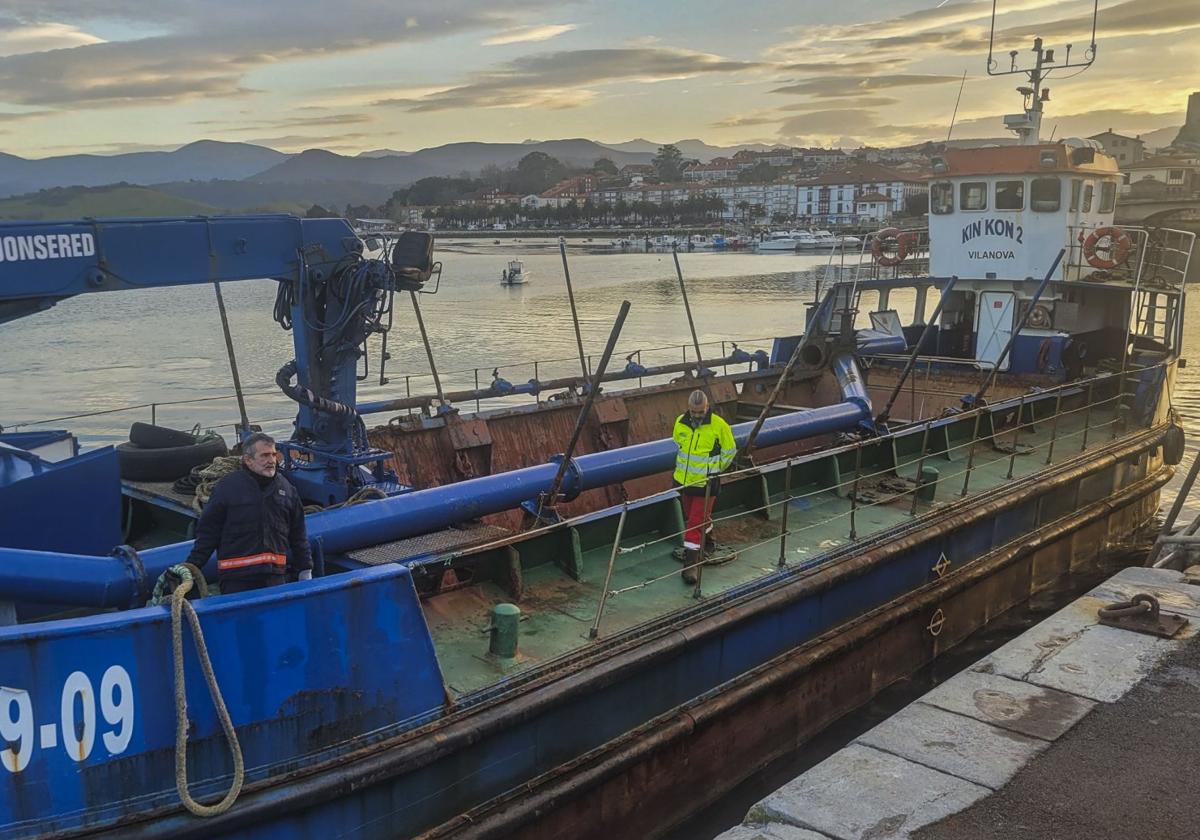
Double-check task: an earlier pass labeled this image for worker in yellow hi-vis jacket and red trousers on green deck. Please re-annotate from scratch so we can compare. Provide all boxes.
[672,391,738,583]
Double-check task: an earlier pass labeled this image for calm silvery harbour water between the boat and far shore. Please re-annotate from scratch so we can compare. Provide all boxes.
[0,239,1200,515]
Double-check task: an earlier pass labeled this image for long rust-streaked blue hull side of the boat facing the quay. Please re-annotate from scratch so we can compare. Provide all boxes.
[96,426,1172,838]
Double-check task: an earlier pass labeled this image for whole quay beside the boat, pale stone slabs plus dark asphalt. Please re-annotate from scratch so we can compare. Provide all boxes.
[718,568,1200,840]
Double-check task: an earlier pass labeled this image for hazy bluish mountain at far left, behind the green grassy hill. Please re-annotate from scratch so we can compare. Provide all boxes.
[0,140,288,196]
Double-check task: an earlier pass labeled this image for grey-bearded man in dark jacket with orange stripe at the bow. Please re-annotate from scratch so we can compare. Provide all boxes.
[187,432,312,595]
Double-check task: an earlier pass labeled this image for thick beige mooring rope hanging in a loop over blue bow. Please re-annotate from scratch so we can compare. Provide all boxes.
[169,565,246,817]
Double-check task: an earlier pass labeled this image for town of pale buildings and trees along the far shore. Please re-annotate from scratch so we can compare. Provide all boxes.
[328,106,1200,233]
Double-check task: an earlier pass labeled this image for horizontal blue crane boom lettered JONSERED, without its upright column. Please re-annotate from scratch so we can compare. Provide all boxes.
[0,215,362,323]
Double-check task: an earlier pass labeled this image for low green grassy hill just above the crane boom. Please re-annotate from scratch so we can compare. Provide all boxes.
[0,184,220,221]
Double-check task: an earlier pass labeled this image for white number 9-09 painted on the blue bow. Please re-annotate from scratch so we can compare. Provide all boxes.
[0,665,133,773]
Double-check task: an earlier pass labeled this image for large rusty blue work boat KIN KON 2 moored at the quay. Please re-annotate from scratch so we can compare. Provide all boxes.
[0,26,1194,838]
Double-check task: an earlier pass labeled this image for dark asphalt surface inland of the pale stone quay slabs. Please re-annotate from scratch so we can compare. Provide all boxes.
[912,638,1200,840]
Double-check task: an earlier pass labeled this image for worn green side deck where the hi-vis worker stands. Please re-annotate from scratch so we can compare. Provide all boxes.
[425,394,1116,696]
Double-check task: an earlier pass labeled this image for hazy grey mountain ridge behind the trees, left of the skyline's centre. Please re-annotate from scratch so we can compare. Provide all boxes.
[247,139,654,186]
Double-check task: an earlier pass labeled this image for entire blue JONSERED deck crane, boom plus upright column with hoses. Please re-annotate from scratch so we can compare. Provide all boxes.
[0,215,424,504]
